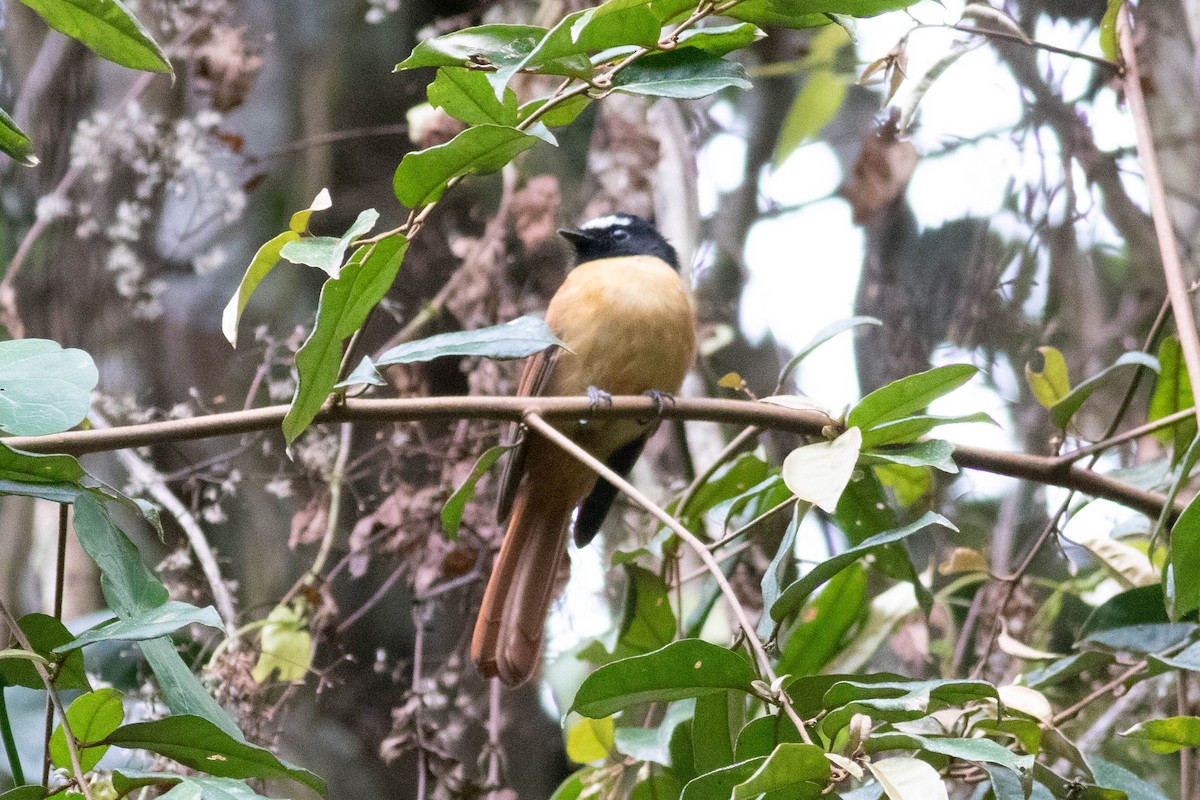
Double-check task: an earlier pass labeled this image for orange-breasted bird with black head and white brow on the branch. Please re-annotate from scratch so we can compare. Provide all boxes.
[470,213,696,686]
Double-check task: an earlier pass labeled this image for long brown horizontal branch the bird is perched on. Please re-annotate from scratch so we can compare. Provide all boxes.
[4,396,1182,516]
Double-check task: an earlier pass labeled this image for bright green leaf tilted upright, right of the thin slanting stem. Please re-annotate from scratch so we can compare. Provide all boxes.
[763,564,866,675]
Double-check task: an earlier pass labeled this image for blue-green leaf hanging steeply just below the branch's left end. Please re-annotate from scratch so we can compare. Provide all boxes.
[74,494,169,619]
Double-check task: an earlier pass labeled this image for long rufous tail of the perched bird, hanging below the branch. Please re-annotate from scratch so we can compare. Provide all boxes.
[470,479,574,686]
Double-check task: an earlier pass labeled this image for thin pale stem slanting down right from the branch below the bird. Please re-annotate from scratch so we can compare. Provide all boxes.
[524,411,812,745]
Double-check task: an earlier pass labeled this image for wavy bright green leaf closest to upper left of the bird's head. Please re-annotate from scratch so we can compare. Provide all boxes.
[392,125,539,209]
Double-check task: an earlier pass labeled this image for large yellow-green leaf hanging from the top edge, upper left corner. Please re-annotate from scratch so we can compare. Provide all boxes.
[22,0,174,74]
